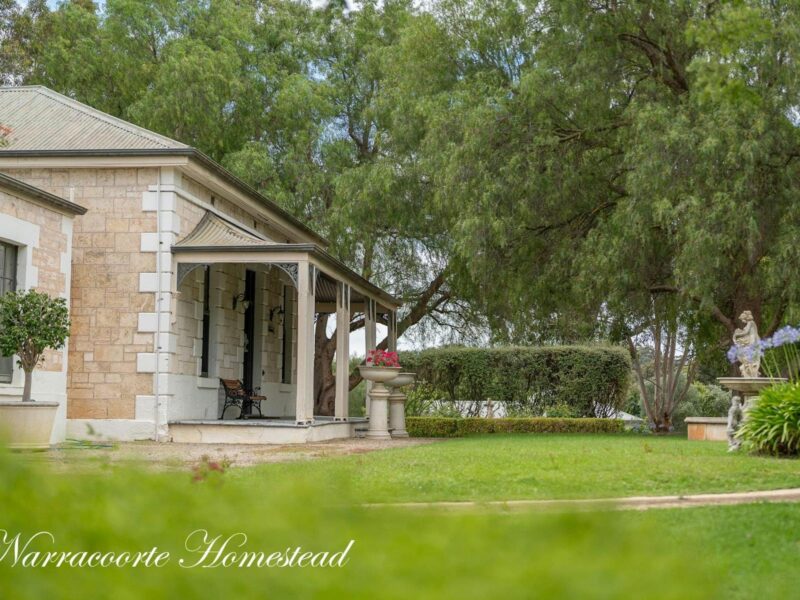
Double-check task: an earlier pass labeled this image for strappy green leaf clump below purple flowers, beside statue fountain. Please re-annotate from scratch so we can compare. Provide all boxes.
[737,383,800,456]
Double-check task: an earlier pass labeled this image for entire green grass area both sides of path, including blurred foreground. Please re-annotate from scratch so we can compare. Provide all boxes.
[6,436,800,600]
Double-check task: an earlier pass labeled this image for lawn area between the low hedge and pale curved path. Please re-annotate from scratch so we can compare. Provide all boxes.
[238,435,800,502]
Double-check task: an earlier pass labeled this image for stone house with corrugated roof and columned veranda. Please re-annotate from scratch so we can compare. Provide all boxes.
[0,86,399,443]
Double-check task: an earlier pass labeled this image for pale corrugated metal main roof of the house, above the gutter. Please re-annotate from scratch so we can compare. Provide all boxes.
[0,86,189,154]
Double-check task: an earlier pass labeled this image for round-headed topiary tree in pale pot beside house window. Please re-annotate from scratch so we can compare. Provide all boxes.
[0,290,69,449]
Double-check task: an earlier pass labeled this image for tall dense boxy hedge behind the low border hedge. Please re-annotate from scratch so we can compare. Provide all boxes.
[400,346,631,417]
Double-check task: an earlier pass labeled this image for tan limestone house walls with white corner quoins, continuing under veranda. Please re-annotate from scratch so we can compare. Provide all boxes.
[3,167,304,439]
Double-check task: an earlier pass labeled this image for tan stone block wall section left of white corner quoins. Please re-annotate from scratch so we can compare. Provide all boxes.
[0,168,158,419]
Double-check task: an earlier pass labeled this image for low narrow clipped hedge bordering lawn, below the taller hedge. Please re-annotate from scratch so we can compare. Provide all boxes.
[406,417,625,437]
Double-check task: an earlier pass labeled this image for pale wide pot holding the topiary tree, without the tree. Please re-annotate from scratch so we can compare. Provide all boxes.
[0,400,58,450]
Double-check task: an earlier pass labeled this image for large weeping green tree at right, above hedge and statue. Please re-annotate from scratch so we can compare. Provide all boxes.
[416,0,800,427]
